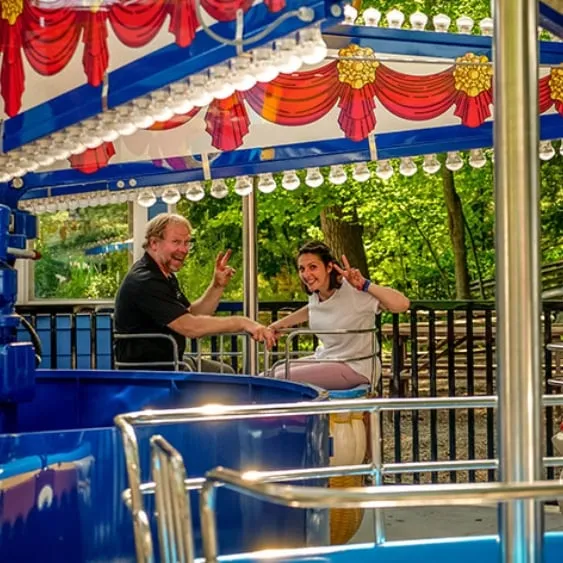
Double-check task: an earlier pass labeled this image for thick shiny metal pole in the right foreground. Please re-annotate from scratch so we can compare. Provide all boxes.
[494,0,543,563]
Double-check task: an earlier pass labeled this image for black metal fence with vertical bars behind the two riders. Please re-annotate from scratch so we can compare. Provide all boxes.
[14,301,563,482]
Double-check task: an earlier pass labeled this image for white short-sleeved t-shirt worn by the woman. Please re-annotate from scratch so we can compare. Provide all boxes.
[309,280,381,380]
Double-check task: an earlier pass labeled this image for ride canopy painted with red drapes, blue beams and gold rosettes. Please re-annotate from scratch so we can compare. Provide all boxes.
[0,0,563,209]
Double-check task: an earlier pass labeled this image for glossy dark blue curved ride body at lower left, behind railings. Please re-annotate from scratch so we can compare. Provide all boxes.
[0,370,328,563]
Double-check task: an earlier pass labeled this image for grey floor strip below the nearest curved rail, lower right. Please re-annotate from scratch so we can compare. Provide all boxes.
[350,506,563,543]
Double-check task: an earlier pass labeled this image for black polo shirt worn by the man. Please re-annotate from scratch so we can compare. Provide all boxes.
[114,253,190,370]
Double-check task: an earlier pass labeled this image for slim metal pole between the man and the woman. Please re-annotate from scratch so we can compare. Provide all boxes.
[242,185,258,375]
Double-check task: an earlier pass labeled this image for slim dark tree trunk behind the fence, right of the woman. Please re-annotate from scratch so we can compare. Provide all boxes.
[442,165,471,299]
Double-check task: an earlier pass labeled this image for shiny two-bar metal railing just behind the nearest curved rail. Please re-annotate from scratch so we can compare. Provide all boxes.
[115,395,563,563]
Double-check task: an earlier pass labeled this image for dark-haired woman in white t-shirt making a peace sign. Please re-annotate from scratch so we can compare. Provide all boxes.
[269,241,410,390]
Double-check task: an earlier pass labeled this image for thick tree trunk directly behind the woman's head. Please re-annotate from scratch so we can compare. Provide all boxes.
[321,205,369,277]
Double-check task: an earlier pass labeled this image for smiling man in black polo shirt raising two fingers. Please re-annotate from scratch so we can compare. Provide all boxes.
[114,213,275,373]
